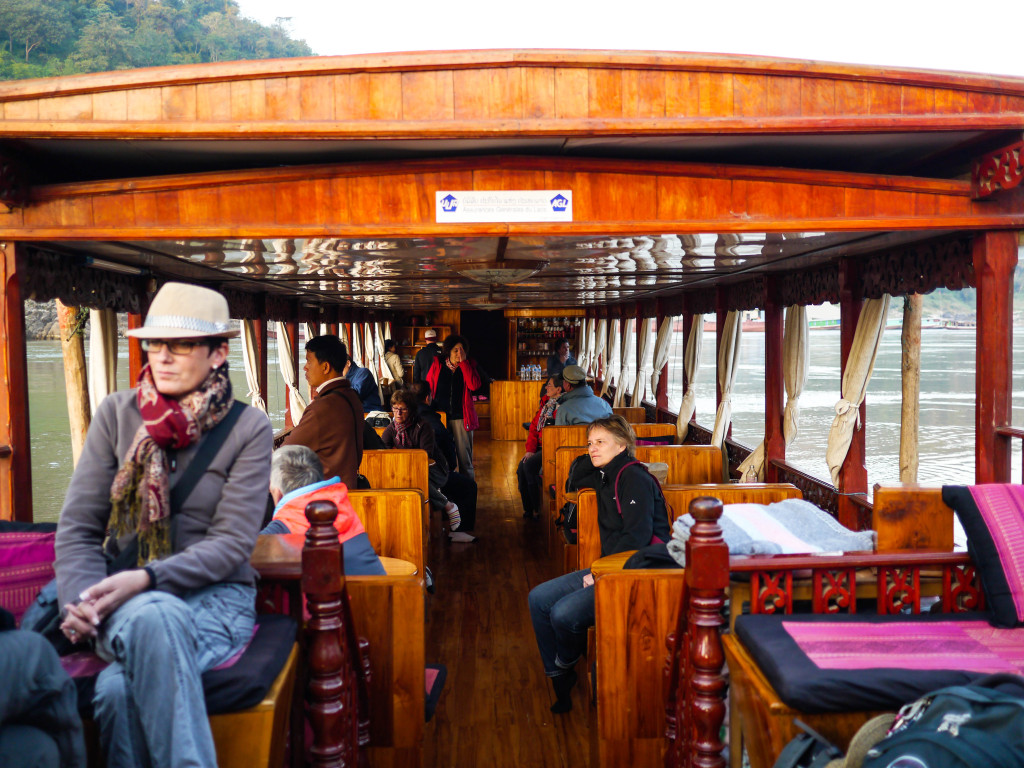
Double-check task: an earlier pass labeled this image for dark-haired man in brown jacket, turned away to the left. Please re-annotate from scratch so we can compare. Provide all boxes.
[284,335,364,488]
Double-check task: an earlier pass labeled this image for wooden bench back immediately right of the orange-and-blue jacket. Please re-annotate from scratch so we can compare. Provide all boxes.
[348,488,425,578]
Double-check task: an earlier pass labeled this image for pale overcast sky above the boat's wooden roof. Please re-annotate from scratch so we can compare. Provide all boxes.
[237,0,1024,76]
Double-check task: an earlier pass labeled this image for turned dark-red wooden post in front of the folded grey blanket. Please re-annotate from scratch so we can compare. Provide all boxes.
[682,497,729,768]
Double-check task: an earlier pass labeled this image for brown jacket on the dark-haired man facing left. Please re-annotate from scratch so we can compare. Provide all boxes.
[283,379,362,488]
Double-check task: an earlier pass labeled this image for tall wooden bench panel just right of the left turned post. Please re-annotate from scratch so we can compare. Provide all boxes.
[345,571,426,768]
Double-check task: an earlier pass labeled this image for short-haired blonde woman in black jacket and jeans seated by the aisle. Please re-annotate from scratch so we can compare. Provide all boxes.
[529,416,672,713]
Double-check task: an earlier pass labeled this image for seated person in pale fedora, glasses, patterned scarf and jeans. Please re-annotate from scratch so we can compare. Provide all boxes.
[54,283,273,767]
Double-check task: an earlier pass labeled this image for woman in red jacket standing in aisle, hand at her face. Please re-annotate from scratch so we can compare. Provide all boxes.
[427,334,480,480]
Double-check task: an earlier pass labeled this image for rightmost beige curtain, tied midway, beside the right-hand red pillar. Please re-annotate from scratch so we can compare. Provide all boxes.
[825,295,889,487]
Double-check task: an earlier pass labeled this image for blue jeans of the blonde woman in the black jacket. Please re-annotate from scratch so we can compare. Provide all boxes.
[529,568,594,677]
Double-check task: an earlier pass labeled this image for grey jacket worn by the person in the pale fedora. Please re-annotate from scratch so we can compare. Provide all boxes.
[54,389,273,606]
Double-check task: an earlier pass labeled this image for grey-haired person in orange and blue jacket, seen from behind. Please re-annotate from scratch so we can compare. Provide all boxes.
[260,445,385,575]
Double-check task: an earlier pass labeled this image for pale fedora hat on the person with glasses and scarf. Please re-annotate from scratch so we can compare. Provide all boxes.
[128,283,239,339]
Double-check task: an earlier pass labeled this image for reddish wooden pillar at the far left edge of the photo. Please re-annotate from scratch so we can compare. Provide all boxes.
[0,242,32,522]
